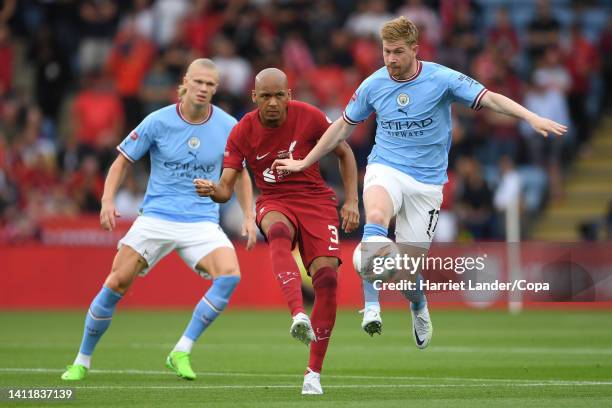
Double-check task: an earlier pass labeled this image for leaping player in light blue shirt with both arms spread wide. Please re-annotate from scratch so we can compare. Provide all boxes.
[273,17,567,349]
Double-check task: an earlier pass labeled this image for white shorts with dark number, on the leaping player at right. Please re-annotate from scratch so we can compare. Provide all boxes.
[363,163,443,248]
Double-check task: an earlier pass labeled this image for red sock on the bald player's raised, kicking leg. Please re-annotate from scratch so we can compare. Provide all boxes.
[268,222,304,316]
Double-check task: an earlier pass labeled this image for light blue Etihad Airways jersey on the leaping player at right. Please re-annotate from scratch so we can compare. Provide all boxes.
[343,61,487,185]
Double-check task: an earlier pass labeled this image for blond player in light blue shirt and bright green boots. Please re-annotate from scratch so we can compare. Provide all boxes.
[61,59,256,380]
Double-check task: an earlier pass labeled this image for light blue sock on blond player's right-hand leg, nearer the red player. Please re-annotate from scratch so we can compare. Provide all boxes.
[183,275,240,341]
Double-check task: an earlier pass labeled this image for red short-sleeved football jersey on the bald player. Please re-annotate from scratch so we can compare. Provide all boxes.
[223,101,335,198]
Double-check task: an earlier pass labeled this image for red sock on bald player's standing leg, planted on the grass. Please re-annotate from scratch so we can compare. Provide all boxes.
[308,266,338,373]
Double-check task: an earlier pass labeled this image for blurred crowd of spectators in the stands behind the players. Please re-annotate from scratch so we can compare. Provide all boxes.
[0,0,612,242]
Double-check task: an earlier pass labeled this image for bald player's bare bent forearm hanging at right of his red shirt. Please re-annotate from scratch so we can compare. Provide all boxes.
[334,141,359,232]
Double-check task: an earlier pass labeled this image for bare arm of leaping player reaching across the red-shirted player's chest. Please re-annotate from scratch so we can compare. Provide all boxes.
[272,118,355,173]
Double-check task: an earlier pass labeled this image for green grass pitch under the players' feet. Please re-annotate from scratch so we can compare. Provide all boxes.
[0,310,612,408]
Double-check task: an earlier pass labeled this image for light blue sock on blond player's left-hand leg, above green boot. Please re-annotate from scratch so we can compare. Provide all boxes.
[79,286,122,356]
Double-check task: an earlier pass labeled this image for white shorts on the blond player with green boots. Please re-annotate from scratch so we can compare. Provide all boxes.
[117,215,234,279]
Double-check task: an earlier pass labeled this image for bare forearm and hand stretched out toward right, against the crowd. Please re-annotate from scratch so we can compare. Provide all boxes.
[481,91,567,137]
